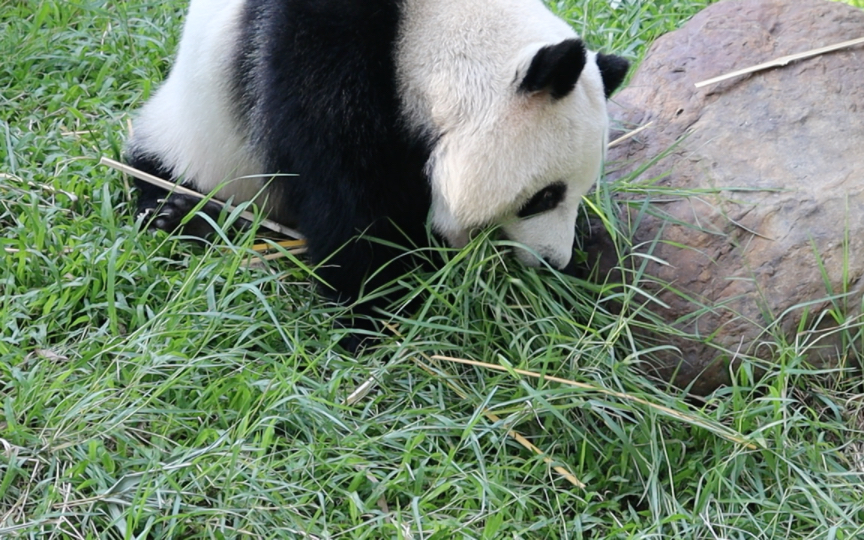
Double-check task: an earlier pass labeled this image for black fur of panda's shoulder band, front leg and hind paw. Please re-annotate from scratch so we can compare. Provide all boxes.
[130,0,431,311]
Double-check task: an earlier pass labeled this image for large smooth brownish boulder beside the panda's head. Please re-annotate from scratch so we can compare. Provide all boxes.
[587,0,864,393]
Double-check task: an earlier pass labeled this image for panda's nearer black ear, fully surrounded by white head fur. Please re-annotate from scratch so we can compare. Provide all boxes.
[519,39,585,99]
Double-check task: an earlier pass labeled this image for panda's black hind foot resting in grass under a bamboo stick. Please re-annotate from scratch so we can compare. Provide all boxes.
[127,153,233,239]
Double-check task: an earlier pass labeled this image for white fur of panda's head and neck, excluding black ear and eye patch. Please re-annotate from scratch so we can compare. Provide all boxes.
[397,0,608,266]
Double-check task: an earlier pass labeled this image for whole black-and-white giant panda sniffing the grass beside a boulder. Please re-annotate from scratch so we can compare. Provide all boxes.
[125,0,628,334]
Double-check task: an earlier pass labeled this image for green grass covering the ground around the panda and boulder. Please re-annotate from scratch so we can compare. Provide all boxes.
[0,0,864,540]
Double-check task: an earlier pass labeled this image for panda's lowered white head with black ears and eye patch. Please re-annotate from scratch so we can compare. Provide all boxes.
[426,38,628,268]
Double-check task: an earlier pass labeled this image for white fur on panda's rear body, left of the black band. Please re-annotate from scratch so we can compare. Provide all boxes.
[132,0,265,207]
